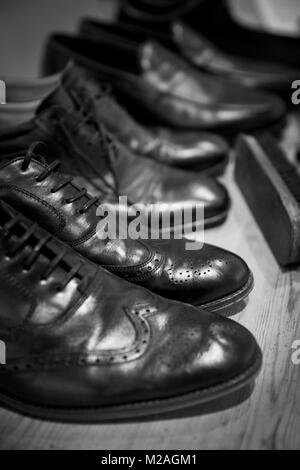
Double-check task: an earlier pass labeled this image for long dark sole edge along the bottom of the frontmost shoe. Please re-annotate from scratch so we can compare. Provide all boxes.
[0,346,262,423]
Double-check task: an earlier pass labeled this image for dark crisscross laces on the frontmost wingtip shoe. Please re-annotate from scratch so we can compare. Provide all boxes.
[3,215,89,292]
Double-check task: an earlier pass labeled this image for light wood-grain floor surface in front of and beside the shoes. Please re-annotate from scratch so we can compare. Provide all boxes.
[0,113,300,450]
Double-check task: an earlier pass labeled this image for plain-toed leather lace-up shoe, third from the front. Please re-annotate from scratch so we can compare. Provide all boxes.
[0,87,230,228]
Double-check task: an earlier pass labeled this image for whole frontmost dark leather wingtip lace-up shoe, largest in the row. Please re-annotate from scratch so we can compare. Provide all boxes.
[0,203,261,422]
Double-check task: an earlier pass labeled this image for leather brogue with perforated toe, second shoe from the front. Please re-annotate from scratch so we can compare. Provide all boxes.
[0,146,253,313]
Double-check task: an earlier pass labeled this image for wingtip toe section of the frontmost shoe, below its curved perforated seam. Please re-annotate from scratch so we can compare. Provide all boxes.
[2,303,261,412]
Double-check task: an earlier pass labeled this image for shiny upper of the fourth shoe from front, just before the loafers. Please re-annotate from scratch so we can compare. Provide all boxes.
[62,66,229,171]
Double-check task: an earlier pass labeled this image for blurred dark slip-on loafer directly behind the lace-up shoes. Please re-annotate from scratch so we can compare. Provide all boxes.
[43,30,286,134]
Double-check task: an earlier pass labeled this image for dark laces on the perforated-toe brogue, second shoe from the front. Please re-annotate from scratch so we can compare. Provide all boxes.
[21,142,99,214]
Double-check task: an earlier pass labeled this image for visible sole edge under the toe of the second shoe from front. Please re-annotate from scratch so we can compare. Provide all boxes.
[197,273,254,316]
